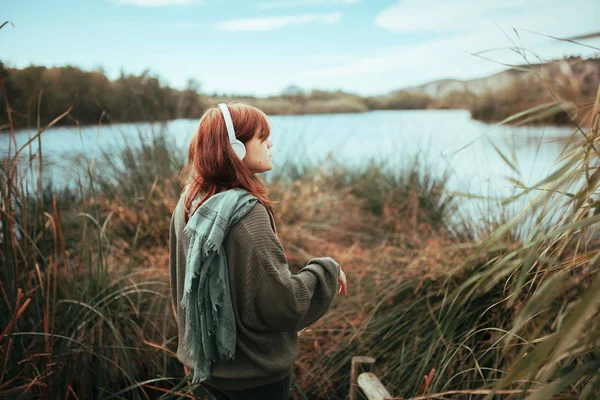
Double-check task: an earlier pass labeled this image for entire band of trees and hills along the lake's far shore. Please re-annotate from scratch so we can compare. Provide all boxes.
[0,59,600,128]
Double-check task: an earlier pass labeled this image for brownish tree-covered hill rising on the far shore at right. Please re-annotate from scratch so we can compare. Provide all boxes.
[377,57,600,124]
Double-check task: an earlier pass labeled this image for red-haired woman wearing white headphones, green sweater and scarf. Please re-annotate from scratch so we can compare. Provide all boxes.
[169,103,347,400]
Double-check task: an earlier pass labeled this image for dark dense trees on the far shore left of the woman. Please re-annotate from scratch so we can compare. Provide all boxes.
[0,64,207,127]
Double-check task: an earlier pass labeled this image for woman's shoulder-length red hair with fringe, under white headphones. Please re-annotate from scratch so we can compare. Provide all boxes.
[180,103,275,230]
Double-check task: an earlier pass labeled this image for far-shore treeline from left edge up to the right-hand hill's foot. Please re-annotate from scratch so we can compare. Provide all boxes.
[0,63,440,128]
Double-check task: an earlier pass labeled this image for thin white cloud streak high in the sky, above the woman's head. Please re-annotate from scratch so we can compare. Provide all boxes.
[214,12,342,31]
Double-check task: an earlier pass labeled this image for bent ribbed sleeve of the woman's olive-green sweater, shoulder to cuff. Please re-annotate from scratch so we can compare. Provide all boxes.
[228,203,340,332]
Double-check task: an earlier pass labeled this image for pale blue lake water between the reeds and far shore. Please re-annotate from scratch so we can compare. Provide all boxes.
[0,110,572,230]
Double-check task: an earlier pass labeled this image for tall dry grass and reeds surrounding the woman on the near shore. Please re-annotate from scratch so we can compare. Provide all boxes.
[0,69,600,399]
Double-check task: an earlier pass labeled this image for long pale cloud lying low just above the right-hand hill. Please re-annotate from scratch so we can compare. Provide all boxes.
[297,30,600,94]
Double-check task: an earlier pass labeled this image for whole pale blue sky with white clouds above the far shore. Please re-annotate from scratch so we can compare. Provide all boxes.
[0,0,600,96]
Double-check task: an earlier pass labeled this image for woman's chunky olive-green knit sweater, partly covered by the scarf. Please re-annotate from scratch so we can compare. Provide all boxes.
[169,191,340,390]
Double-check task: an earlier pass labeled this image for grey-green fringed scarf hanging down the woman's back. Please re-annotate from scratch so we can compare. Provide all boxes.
[181,189,258,383]
